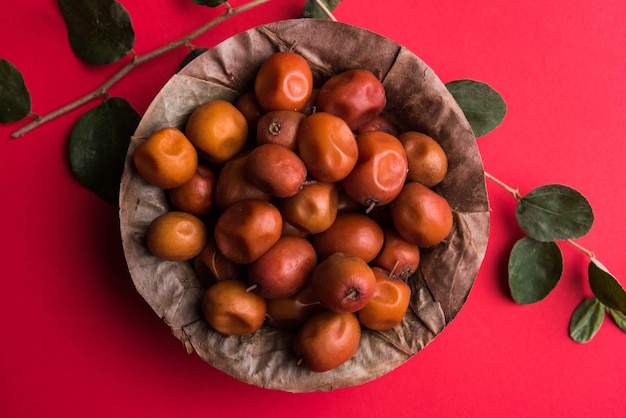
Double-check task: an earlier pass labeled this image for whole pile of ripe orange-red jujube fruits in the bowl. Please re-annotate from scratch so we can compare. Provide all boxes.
[133,51,453,372]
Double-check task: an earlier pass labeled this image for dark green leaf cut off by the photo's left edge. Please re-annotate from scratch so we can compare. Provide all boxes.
[0,58,31,123]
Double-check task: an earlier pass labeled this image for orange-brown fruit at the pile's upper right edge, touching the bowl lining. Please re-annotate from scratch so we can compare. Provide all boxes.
[398,131,448,187]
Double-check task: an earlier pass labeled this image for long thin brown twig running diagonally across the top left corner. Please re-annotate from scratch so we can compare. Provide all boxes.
[11,0,271,138]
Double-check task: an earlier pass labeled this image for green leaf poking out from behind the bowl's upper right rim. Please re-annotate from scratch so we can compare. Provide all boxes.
[446,80,506,138]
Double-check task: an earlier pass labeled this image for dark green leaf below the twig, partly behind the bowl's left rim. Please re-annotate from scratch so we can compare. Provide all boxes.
[69,97,141,204]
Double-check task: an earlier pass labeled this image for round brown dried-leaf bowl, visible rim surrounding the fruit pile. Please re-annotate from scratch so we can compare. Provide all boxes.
[120,19,489,392]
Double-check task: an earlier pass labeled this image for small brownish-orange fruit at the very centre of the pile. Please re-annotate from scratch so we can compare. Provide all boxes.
[276,182,339,234]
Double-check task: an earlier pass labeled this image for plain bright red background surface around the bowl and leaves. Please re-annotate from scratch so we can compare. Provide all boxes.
[0,0,626,417]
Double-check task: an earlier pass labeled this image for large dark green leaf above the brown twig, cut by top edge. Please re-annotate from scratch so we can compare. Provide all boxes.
[57,0,135,65]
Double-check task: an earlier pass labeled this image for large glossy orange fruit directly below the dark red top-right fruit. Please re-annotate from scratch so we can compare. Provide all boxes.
[297,112,359,182]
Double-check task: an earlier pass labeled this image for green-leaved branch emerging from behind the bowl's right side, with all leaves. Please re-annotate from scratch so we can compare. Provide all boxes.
[446,86,626,343]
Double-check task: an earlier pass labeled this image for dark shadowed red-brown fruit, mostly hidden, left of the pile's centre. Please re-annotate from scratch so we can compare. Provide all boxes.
[215,153,271,210]
